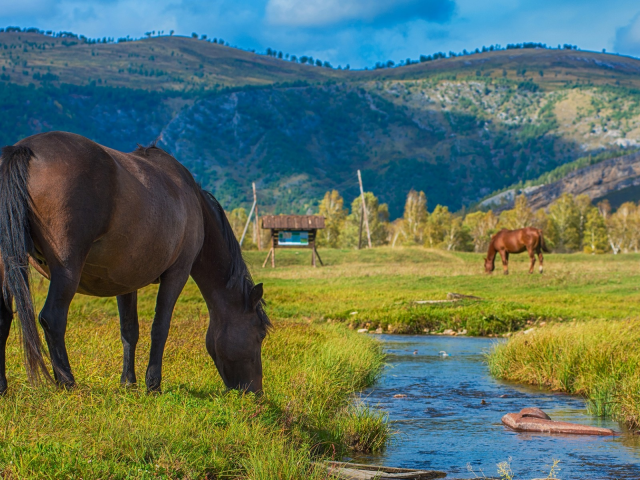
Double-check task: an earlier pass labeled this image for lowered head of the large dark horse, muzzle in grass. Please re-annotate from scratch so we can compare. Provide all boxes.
[206,283,269,393]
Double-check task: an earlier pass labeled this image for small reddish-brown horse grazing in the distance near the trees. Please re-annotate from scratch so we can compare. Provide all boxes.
[484,227,549,275]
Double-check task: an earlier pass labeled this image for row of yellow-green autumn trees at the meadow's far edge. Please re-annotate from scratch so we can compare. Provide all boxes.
[228,190,640,254]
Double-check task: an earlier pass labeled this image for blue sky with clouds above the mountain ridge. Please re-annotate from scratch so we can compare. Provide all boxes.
[0,0,640,68]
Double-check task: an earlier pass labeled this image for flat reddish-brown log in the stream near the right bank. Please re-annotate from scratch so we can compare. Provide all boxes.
[502,408,617,435]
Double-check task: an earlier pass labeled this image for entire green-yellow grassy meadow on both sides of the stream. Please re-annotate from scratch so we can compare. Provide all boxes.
[0,248,640,479]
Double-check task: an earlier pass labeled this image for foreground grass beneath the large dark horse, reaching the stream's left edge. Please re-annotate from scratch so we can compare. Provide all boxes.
[0,281,388,480]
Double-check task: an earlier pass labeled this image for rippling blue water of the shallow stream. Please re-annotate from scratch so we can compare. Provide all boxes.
[354,335,640,480]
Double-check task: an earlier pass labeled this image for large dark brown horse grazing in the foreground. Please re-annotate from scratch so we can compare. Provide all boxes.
[0,132,270,394]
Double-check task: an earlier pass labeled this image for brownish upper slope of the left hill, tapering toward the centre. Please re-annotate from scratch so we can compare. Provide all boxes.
[0,32,342,91]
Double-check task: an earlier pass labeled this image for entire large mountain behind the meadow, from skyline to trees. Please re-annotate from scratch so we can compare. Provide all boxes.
[0,32,640,217]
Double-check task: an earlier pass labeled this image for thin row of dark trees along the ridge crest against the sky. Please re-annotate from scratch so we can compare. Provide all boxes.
[0,27,578,70]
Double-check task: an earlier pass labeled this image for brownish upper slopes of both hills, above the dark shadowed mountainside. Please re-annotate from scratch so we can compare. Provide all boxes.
[0,32,640,90]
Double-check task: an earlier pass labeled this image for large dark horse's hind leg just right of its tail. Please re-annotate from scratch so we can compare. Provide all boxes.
[40,267,81,388]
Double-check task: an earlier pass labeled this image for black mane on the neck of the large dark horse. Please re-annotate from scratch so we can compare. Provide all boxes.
[200,188,271,327]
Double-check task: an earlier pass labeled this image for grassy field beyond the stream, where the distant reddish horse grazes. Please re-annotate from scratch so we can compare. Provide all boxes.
[246,247,640,335]
